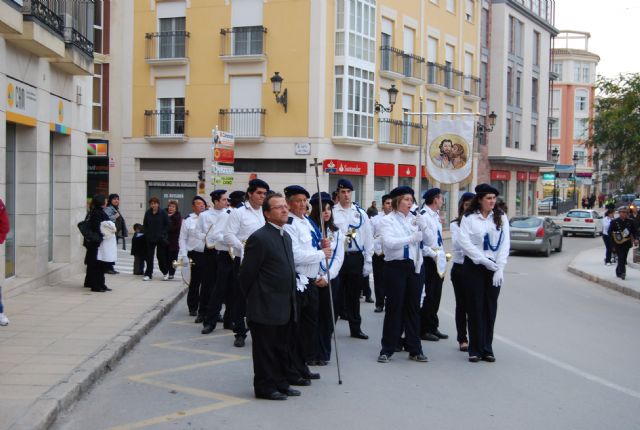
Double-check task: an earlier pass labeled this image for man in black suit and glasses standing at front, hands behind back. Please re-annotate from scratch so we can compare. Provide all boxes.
[239,193,300,400]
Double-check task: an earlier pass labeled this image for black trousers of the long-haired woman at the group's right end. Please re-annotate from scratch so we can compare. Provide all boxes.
[462,257,500,357]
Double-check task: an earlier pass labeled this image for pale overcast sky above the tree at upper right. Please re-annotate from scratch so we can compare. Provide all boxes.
[555,0,640,78]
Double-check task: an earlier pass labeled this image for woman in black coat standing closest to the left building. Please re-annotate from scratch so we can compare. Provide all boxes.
[84,194,111,293]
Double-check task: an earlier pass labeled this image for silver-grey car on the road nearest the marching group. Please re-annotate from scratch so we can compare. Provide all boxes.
[509,216,562,257]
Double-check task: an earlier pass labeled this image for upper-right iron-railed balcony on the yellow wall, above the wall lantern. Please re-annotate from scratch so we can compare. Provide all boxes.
[220,26,267,63]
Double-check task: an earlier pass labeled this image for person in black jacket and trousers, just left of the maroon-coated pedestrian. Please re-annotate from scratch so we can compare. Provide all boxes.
[142,197,169,281]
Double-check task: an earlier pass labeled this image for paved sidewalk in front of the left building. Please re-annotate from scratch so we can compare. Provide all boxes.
[0,254,186,430]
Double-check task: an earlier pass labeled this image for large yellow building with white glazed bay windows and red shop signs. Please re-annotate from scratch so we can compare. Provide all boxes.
[115,0,480,227]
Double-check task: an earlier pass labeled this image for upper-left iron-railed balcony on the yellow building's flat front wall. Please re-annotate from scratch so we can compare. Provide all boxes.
[144,30,190,66]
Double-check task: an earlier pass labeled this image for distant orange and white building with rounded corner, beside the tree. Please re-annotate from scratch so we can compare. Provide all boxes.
[543,30,602,202]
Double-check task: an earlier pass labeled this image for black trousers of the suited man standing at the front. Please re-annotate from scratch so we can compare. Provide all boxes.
[249,321,292,396]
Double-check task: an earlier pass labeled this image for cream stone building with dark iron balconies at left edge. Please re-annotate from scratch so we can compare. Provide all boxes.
[0,0,94,289]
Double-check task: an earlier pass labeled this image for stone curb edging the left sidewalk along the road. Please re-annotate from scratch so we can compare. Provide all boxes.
[9,288,187,430]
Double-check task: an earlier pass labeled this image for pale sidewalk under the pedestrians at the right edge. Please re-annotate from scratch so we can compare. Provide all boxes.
[567,247,640,299]
